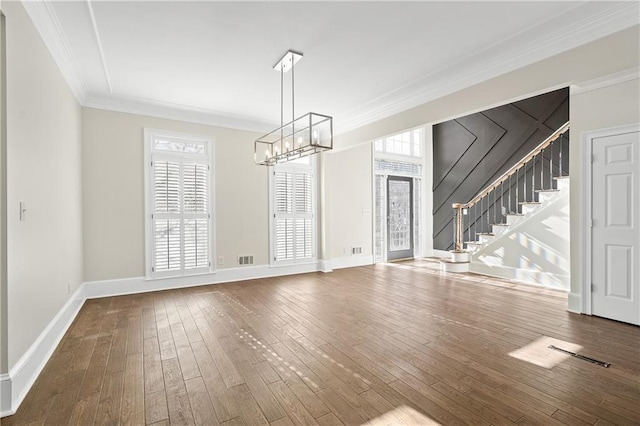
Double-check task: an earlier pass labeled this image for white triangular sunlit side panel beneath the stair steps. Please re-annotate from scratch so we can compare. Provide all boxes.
[469,184,570,291]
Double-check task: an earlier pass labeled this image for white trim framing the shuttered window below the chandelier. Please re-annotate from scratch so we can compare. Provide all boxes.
[269,156,319,268]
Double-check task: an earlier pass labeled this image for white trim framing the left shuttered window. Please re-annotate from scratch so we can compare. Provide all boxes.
[144,128,216,280]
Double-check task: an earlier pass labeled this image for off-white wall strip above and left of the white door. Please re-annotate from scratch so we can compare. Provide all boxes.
[569,78,640,312]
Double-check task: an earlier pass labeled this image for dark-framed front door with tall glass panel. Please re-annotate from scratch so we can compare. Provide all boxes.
[387,176,413,260]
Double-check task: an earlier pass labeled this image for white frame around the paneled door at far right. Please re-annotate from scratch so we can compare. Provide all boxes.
[580,123,640,315]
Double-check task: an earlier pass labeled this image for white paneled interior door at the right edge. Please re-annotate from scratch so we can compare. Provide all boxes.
[591,131,640,325]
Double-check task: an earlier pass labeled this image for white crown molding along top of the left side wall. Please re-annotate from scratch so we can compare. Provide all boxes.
[21,0,89,104]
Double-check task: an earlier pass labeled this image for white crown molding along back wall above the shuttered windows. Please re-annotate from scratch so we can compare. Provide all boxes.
[82,95,279,133]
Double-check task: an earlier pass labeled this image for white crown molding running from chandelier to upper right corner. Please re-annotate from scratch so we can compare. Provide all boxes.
[336,1,640,134]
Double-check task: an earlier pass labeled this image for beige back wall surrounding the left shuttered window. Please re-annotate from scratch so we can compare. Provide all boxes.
[82,108,269,281]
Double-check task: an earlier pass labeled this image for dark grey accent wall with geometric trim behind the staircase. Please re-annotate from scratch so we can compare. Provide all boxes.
[433,88,569,250]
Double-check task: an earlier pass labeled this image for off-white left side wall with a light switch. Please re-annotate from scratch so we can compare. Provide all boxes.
[3,2,82,368]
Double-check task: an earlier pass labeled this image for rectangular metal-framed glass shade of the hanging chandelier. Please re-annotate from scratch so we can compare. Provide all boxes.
[254,112,333,166]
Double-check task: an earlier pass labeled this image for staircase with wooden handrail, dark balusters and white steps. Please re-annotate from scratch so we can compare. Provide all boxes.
[440,122,569,287]
